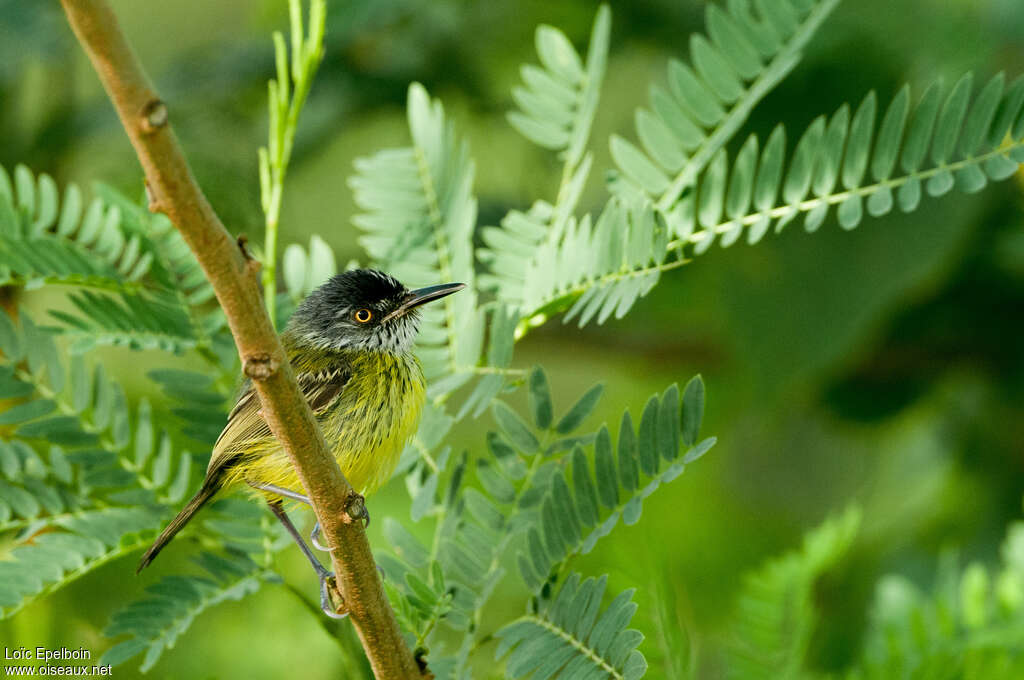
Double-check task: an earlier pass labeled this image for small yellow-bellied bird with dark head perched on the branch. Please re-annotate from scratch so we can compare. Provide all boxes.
[136,269,465,617]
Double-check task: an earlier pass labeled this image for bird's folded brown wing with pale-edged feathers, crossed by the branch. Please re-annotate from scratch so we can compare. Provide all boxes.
[207,369,351,476]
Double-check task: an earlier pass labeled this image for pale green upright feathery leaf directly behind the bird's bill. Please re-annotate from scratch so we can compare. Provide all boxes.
[349,84,483,391]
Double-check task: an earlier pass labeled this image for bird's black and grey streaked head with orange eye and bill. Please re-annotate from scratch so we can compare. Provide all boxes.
[287,269,466,353]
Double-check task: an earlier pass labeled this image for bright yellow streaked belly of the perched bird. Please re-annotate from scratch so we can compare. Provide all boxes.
[229,353,426,496]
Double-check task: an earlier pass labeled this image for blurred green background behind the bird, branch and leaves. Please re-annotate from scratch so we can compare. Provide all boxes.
[0,0,1024,679]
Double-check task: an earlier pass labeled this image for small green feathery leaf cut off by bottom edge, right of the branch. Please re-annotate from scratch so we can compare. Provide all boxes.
[495,573,647,680]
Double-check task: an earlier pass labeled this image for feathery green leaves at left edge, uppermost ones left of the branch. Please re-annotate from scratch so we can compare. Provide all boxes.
[0,166,224,353]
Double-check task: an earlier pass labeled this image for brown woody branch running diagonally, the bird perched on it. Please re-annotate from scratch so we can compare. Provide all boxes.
[61,0,420,678]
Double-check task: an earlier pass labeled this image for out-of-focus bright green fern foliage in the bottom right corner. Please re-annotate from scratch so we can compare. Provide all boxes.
[726,508,1024,680]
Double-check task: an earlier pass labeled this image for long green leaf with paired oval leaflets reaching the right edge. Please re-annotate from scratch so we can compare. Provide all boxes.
[667,74,1024,253]
